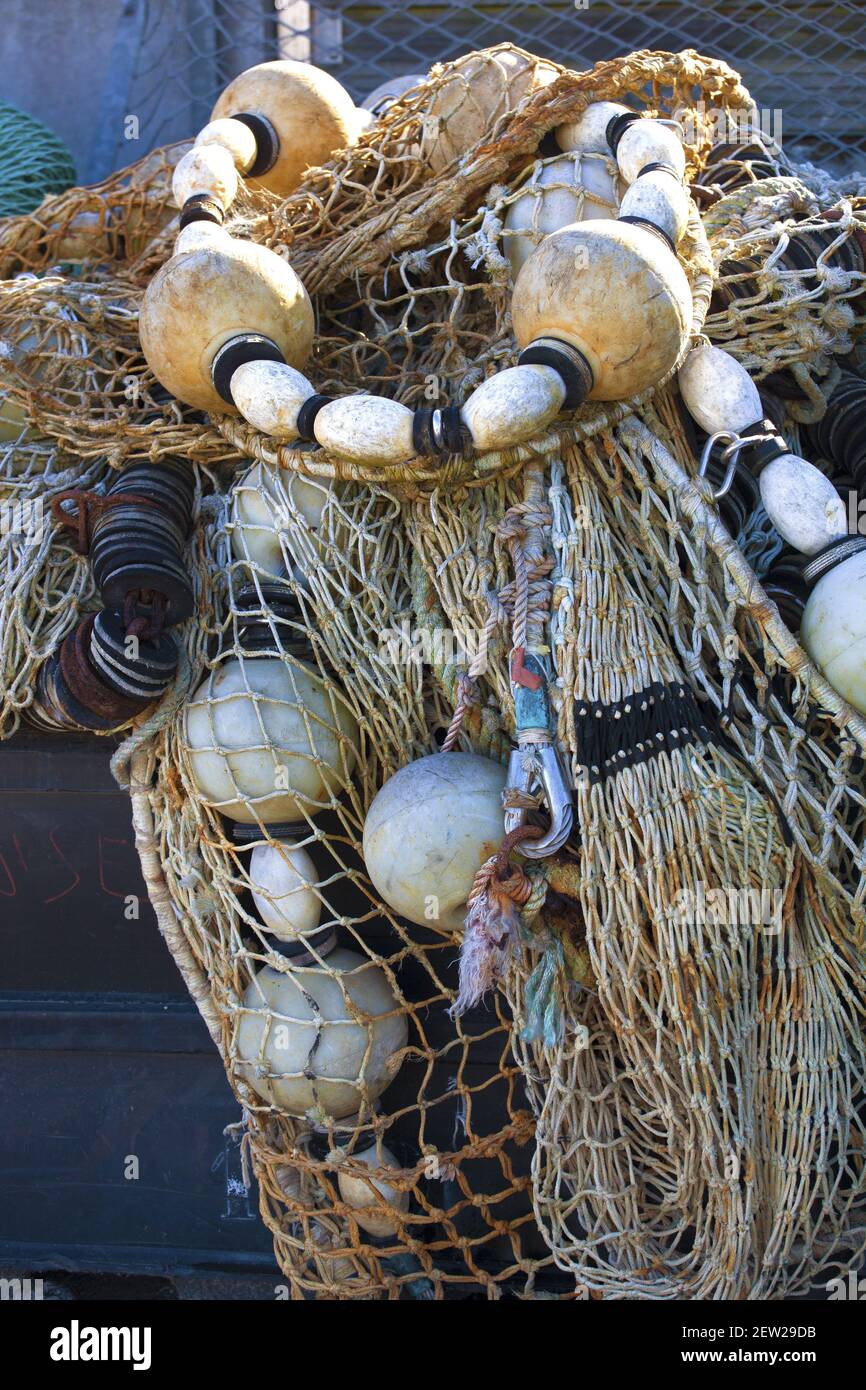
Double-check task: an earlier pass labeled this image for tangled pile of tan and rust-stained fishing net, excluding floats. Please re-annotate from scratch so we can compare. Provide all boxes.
[0,53,866,1298]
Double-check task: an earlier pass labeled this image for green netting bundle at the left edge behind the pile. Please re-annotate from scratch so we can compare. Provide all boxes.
[0,101,75,217]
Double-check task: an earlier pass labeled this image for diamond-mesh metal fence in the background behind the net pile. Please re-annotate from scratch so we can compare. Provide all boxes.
[89,0,866,177]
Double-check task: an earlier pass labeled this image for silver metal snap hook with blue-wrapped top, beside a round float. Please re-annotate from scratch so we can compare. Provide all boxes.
[505,648,574,859]
